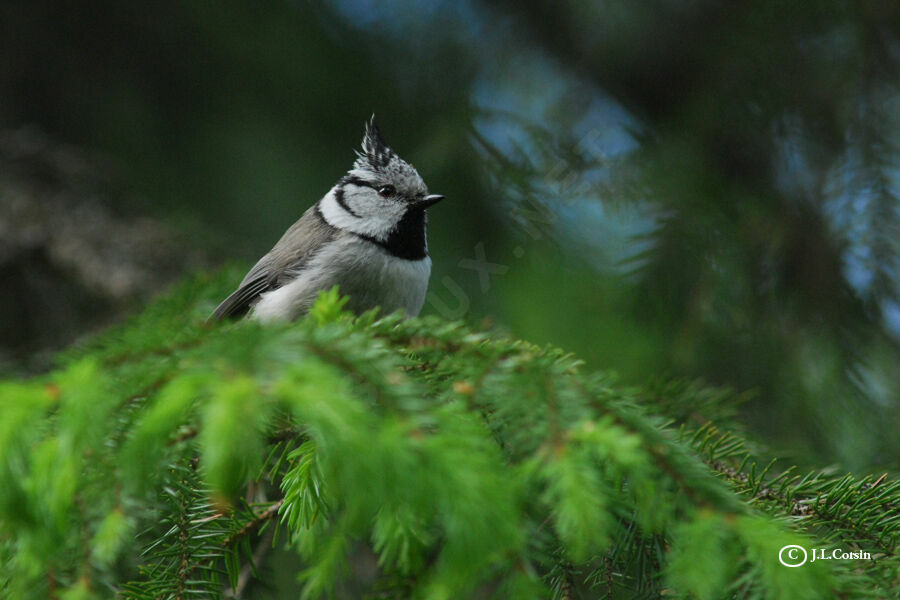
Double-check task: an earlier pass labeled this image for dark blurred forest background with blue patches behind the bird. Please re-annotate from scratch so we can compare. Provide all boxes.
[0,0,900,471]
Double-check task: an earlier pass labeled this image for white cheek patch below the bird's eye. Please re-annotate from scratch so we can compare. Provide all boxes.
[319,184,406,241]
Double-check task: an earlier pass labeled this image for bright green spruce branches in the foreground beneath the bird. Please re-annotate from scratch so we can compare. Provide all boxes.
[0,271,900,599]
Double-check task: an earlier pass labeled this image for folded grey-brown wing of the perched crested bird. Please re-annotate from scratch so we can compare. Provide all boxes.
[209,205,338,321]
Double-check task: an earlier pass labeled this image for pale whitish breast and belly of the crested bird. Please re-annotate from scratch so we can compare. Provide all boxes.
[252,235,431,321]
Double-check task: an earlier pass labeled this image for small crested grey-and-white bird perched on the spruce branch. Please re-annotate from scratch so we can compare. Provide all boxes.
[209,114,444,322]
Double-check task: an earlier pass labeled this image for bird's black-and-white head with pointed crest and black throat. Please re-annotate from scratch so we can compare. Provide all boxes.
[319,115,436,260]
